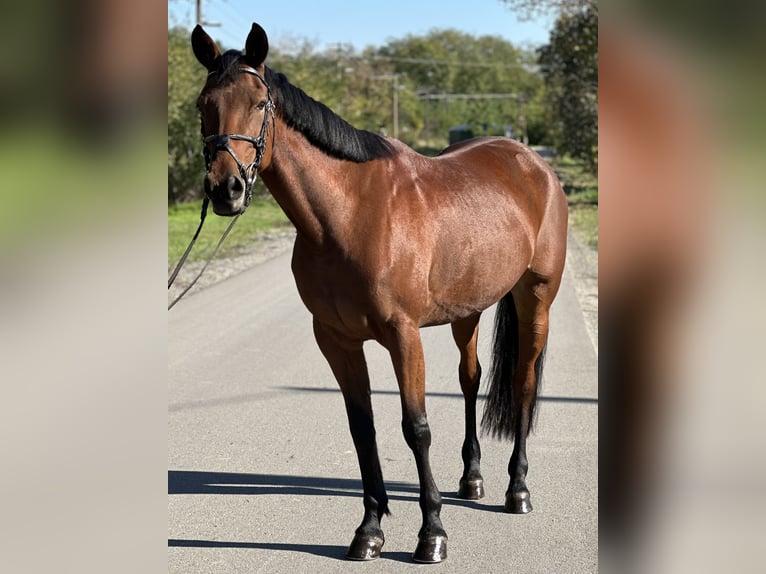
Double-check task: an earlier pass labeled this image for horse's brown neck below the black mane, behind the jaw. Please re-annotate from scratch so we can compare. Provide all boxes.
[261,120,368,247]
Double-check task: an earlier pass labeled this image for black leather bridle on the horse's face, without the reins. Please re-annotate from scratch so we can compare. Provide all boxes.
[202,66,274,207]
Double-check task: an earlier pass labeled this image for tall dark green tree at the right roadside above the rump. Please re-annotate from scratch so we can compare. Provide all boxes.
[539,2,598,173]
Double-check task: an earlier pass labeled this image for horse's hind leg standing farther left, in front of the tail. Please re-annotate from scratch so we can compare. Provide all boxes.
[452,314,484,500]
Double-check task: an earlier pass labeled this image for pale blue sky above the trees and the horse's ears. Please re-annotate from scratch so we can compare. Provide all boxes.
[168,0,553,50]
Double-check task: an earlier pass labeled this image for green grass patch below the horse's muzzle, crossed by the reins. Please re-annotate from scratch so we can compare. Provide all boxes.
[168,196,292,267]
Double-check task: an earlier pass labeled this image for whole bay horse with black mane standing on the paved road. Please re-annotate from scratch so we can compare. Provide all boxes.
[191,24,568,563]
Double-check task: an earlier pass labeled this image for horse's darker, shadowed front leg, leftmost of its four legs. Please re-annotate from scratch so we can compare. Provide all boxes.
[314,320,389,560]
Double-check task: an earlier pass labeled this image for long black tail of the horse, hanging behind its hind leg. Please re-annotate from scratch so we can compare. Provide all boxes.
[481,293,545,439]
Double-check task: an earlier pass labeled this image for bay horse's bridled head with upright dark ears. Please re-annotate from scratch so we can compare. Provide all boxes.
[192,24,274,215]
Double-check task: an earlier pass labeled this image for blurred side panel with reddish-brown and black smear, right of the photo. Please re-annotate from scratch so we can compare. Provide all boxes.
[599,2,766,572]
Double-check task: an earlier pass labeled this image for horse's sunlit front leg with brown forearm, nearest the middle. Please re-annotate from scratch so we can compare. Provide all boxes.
[384,322,447,563]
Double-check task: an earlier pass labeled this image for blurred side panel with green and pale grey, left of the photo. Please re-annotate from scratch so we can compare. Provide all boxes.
[0,0,167,572]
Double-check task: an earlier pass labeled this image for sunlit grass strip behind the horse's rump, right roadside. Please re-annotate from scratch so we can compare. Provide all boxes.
[552,157,598,249]
